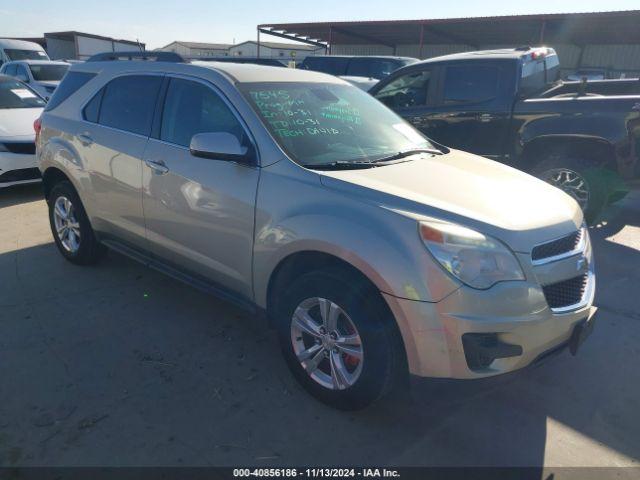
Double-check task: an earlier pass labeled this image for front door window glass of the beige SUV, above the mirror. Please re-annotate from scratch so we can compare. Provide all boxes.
[160,78,245,147]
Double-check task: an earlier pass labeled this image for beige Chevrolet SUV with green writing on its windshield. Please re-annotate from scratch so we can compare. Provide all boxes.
[37,54,595,408]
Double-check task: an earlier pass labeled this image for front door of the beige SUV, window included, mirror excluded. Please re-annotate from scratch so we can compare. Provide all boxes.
[143,77,260,298]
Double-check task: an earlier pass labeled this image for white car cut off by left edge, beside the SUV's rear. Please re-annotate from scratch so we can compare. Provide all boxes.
[0,75,45,188]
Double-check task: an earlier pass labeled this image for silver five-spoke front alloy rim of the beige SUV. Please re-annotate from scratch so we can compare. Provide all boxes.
[291,297,364,390]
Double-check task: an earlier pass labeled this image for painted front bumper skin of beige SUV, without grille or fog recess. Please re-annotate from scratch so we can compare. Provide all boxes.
[383,284,596,379]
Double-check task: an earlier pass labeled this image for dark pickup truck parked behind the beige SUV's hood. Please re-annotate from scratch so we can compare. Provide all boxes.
[370,47,640,221]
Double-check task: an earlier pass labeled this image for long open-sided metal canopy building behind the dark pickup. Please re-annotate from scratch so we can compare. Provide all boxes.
[258,10,640,77]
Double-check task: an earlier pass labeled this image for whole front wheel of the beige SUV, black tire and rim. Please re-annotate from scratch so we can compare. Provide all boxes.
[276,269,408,410]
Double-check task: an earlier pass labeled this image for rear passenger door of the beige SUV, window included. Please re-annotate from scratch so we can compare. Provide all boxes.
[74,73,163,248]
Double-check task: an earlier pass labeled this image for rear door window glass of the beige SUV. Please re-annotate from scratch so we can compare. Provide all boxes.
[98,75,162,135]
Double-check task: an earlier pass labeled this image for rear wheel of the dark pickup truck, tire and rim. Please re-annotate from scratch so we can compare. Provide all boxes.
[531,155,613,224]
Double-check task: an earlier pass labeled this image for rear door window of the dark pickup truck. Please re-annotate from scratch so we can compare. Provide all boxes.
[444,65,500,105]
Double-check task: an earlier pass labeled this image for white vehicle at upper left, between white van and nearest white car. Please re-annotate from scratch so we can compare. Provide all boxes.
[0,60,70,100]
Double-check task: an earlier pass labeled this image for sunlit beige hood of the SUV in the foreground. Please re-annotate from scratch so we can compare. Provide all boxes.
[319,150,582,252]
